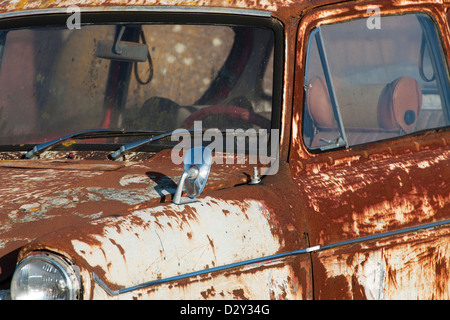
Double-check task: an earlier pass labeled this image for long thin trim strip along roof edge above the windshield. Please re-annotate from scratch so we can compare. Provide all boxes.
[0,6,272,19]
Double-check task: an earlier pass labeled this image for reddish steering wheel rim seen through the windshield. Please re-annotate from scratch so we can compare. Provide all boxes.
[183,105,271,129]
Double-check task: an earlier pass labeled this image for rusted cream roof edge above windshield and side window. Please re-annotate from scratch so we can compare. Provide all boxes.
[0,0,442,20]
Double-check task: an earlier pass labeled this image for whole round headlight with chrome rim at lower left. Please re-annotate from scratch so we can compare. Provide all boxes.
[11,252,80,300]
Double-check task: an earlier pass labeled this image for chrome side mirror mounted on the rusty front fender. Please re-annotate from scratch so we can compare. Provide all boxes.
[173,147,212,204]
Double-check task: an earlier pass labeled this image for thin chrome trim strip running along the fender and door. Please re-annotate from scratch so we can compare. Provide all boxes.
[93,219,450,296]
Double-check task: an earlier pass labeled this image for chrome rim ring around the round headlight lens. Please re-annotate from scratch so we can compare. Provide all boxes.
[10,251,81,300]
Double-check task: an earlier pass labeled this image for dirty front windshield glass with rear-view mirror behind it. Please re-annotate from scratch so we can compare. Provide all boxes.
[0,23,274,145]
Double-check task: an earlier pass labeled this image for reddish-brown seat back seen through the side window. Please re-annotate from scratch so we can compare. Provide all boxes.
[306,77,422,148]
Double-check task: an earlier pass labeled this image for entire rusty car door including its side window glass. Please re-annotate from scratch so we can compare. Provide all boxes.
[290,2,450,299]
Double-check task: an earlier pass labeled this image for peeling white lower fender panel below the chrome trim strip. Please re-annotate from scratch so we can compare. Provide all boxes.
[86,255,311,300]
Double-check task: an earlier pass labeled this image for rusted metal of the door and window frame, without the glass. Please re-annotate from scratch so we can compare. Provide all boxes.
[290,1,450,299]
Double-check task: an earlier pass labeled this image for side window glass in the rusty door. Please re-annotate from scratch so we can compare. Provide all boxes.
[303,15,449,150]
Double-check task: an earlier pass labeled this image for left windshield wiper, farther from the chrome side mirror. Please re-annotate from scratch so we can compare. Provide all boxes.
[23,129,161,159]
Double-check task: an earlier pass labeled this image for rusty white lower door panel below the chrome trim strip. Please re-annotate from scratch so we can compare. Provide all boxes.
[313,227,450,300]
